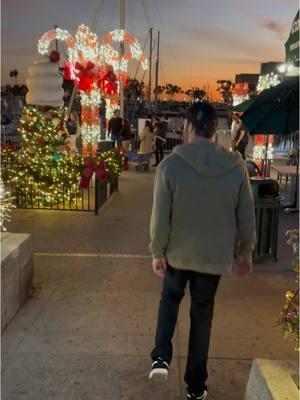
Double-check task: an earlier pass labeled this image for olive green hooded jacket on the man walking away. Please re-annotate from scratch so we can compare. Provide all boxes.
[150,139,255,274]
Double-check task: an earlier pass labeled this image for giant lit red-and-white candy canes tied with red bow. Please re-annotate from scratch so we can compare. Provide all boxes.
[38,25,148,155]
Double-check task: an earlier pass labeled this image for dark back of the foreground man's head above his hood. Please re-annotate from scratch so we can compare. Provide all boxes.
[185,101,218,139]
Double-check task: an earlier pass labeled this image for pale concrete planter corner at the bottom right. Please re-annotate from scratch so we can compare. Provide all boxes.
[245,359,299,400]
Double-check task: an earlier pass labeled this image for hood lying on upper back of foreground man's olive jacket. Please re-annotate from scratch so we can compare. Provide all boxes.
[173,140,242,176]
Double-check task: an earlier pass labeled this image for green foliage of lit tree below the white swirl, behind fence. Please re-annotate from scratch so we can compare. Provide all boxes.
[2,106,83,207]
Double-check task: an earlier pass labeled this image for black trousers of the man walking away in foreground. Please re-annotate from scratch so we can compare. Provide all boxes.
[151,266,220,394]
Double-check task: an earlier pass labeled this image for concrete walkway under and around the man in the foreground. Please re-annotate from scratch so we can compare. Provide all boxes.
[2,172,297,400]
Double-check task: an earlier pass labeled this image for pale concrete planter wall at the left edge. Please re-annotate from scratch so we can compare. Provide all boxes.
[1,233,33,332]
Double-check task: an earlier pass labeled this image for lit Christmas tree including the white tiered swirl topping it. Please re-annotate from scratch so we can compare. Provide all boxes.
[4,56,83,206]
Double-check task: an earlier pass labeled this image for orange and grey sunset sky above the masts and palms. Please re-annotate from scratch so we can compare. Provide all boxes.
[1,0,298,98]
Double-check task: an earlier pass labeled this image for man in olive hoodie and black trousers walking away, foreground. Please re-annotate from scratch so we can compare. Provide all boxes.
[149,102,255,400]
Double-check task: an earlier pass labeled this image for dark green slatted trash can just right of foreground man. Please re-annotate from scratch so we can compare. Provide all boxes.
[250,177,280,261]
